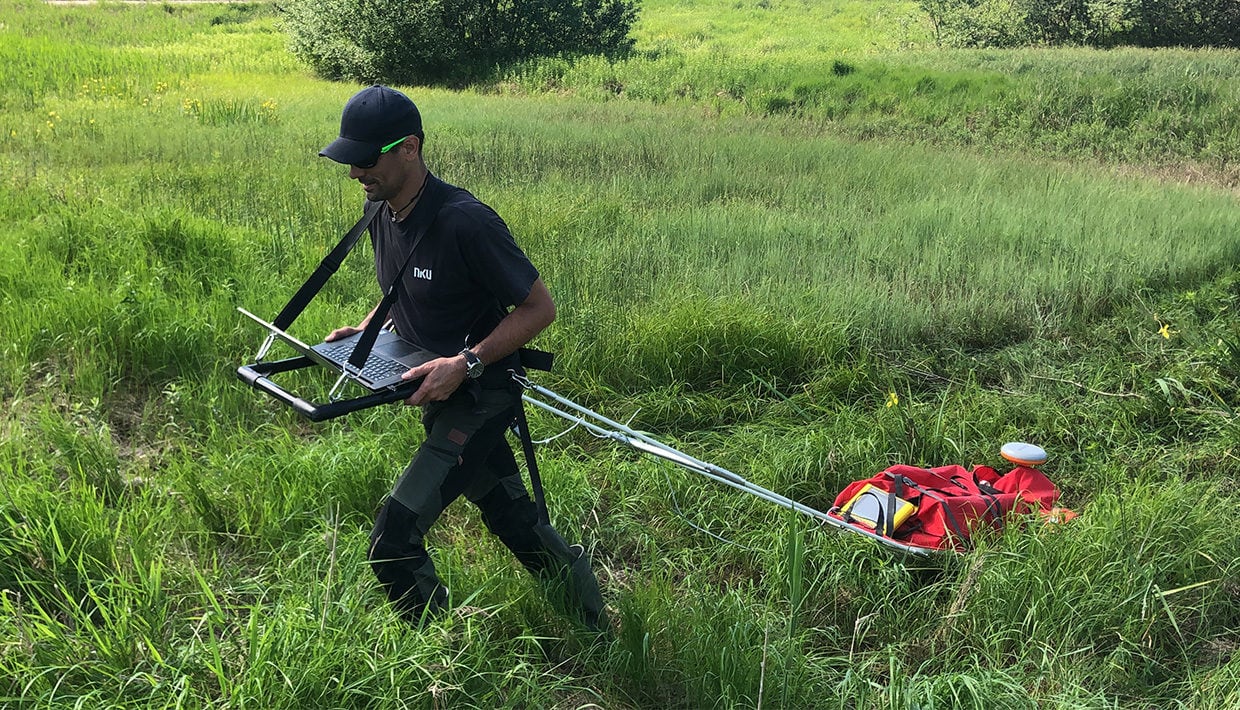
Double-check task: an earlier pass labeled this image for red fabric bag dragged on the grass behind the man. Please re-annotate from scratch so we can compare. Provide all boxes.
[827,465,1059,550]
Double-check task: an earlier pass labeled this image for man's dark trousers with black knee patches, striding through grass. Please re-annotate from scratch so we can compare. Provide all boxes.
[368,388,605,628]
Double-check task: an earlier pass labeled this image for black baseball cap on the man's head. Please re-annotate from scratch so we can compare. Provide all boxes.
[319,84,422,165]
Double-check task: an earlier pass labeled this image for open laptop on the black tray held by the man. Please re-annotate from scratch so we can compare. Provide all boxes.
[237,307,439,390]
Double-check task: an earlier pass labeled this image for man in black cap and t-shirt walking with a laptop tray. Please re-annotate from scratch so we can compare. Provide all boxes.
[319,85,606,629]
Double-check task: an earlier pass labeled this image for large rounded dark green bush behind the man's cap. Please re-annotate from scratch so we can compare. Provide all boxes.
[280,0,637,84]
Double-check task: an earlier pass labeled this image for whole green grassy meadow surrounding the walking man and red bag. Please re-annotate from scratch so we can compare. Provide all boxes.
[0,0,1240,710]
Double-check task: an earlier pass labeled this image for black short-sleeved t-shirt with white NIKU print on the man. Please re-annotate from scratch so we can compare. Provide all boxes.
[370,175,538,384]
